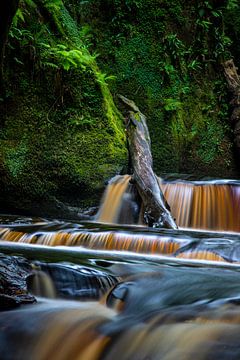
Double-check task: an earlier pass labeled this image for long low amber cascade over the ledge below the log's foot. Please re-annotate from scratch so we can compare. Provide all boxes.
[0,222,240,263]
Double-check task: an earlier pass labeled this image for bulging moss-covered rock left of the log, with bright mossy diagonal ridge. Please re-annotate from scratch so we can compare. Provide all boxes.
[0,1,127,205]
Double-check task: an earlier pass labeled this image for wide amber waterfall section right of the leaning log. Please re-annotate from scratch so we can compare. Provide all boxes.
[162,182,240,232]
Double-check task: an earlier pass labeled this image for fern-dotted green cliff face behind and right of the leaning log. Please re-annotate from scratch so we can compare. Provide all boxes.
[80,0,240,176]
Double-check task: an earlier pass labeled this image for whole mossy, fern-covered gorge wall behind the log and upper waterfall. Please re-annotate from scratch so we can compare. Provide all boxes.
[0,0,240,214]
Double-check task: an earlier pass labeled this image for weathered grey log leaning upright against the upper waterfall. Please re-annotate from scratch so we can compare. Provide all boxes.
[119,95,177,229]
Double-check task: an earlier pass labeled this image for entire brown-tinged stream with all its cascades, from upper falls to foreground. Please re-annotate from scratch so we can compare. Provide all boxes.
[0,176,240,360]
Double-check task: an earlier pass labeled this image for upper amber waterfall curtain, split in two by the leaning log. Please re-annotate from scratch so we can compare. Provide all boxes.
[96,175,240,232]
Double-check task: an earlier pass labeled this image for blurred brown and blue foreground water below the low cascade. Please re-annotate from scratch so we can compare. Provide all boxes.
[0,263,240,360]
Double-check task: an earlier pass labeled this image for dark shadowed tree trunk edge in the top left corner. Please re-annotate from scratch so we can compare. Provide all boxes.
[0,0,19,97]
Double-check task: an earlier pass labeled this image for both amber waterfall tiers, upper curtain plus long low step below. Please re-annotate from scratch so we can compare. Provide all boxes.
[0,175,240,262]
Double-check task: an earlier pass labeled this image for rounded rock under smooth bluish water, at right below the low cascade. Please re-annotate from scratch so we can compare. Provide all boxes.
[106,267,240,319]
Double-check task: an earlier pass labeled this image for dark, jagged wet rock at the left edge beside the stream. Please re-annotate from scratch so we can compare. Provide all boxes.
[0,253,36,311]
